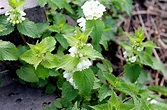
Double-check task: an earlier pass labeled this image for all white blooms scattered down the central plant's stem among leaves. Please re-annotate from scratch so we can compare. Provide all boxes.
[63,44,92,89]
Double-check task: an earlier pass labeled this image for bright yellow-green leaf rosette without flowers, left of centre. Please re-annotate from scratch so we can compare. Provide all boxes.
[20,37,58,68]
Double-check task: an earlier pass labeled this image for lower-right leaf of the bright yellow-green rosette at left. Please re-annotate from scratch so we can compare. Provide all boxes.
[41,53,59,69]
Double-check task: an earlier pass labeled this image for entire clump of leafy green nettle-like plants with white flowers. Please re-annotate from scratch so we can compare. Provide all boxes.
[0,0,167,110]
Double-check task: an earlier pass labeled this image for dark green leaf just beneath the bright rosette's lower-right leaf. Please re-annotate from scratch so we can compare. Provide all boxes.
[35,65,49,80]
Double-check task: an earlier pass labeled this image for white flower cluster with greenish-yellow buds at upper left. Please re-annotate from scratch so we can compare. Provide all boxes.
[5,9,26,25]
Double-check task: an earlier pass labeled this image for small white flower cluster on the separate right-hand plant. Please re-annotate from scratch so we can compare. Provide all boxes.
[123,51,137,63]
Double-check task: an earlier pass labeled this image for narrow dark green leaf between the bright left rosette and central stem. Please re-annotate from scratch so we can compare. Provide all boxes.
[55,34,68,49]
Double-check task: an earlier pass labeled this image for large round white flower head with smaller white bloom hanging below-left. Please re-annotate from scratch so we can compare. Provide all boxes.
[77,0,106,31]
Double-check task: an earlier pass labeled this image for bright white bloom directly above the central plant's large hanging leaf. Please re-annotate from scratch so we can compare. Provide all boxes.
[77,59,92,71]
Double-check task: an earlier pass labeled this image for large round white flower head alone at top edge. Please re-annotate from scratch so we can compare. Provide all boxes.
[81,0,106,20]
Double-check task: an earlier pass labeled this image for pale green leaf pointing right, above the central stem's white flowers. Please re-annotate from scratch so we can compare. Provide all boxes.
[79,45,103,60]
